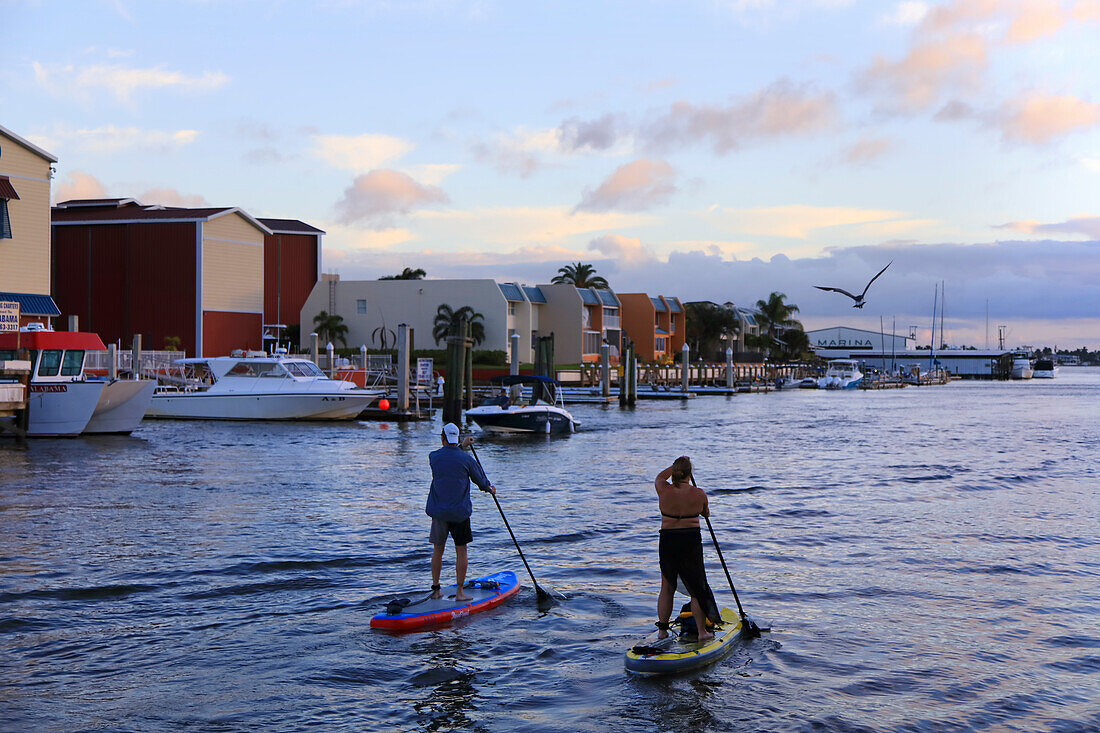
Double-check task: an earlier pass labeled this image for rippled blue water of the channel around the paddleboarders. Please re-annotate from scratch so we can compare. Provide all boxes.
[0,369,1100,732]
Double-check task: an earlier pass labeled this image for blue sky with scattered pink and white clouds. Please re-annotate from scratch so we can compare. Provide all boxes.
[0,0,1100,349]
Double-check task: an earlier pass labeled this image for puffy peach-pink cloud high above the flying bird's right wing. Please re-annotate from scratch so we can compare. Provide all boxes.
[858,34,987,112]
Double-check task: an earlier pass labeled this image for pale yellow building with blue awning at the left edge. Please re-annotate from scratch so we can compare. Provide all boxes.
[0,127,59,324]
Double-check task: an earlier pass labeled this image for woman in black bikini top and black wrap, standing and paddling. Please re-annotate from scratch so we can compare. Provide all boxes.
[653,456,722,641]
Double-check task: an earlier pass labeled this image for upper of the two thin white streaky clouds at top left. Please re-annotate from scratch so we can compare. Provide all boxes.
[32,62,229,101]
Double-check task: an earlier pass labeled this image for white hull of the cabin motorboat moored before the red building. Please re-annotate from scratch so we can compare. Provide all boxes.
[145,392,378,420]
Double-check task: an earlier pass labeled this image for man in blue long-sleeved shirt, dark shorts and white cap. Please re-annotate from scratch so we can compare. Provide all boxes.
[424,423,497,601]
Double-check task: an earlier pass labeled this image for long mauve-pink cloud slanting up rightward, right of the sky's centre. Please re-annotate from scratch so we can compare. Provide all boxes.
[640,80,836,153]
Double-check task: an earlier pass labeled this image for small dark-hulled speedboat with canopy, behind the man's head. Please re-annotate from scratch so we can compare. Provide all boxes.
[466,374,578,435]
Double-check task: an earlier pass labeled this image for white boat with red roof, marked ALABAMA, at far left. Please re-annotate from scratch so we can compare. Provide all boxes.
[0,324,107,437]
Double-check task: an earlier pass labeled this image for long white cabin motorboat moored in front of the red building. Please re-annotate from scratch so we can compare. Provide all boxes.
[146,351,385,420]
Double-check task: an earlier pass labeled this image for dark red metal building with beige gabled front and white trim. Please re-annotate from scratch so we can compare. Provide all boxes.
[52,199,273,357]
